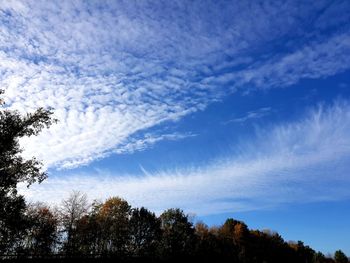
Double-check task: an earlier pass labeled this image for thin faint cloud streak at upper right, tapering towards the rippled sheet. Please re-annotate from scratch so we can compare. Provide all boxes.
[202,32,350,89]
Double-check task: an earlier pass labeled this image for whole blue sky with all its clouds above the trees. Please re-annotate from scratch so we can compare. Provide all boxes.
[0,0,350,255]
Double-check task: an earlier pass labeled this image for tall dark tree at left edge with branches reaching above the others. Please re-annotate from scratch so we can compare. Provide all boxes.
[0,91,56,253]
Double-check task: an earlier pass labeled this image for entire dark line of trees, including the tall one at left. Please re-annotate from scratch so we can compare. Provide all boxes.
[0,94,348,263]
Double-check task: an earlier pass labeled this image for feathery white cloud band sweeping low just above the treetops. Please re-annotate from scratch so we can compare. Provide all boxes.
[22,101,350,215]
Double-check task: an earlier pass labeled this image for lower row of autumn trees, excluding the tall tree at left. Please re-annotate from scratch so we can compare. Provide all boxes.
[1,192,348,263]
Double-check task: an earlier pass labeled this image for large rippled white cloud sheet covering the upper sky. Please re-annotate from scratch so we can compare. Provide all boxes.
[0,1,350,167]
